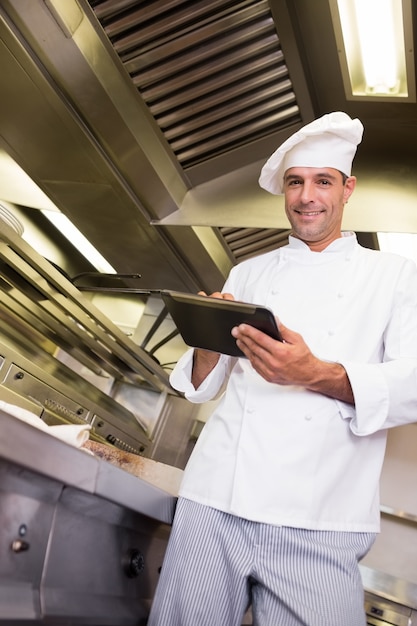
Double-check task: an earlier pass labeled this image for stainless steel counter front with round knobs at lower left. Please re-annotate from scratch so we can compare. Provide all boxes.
[0,412,175,626]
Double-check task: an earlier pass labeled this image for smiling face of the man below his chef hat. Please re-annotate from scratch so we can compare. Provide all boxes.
[284,167,356,252]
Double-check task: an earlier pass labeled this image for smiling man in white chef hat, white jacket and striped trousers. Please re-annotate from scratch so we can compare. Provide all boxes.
[149,112,417,626]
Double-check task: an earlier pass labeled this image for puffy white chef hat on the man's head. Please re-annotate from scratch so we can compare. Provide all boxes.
[259,111,363,195]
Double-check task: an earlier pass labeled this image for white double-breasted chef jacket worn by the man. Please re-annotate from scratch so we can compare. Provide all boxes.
[171,233,417,532]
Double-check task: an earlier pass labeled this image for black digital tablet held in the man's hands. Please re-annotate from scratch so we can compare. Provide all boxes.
[161,290,282,357]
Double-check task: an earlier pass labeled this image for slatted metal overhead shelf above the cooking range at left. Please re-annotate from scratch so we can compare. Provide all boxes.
[0,219,170,389]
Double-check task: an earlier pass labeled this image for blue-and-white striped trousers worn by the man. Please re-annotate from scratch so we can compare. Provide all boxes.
[148,498,375,626]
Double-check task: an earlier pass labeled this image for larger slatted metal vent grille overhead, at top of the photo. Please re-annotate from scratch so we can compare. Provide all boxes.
[90,0,301,169]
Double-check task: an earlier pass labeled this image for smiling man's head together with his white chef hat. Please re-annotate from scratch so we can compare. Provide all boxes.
[259,112,363,252]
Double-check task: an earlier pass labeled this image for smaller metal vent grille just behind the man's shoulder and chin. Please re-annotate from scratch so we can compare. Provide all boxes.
[219,227,291,263]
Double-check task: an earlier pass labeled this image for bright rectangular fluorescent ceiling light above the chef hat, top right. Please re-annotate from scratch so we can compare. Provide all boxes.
[329,0,416,102]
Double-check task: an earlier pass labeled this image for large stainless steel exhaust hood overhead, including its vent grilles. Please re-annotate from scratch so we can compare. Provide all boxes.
[0,0,417,306]
